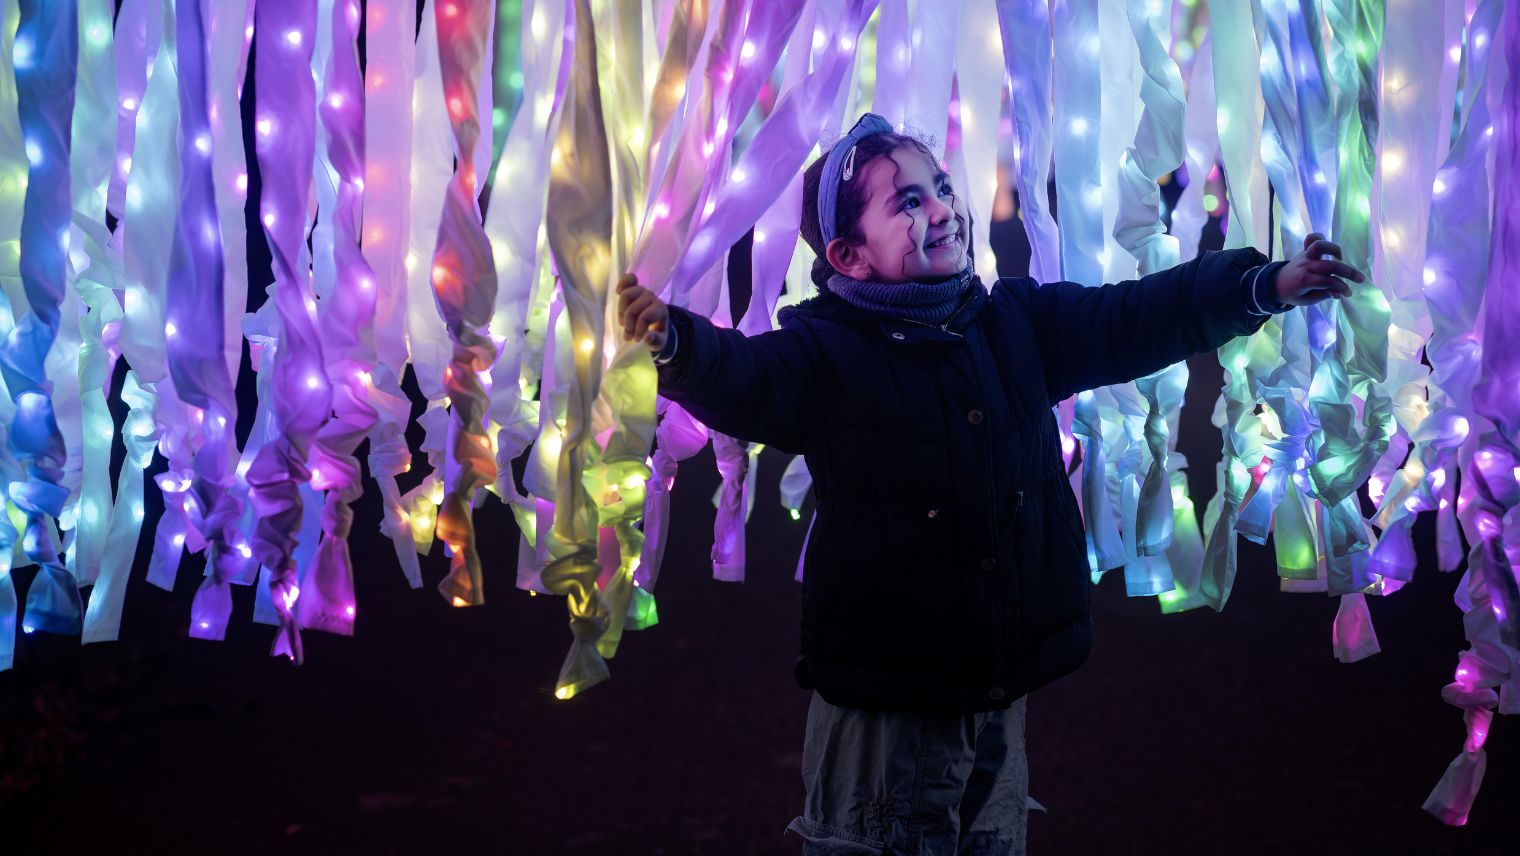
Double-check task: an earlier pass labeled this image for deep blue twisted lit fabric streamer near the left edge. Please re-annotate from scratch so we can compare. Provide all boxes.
[0,0,84,634]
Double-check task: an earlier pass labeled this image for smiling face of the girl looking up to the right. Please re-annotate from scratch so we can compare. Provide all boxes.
[827,146,970,283]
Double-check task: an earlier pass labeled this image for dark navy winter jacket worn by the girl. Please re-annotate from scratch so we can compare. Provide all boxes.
[660,249,1275,713]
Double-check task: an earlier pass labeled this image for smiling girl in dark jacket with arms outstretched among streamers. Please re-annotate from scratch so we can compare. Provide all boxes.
[617,114,1362,854]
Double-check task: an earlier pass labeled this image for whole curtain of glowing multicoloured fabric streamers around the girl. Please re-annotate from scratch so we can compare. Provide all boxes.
[0,0,1520,824]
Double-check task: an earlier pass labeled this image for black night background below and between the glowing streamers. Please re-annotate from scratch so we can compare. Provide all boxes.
[0,5,1520,854]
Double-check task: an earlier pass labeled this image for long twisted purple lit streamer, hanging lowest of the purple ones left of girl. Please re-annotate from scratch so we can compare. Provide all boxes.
[248,0,331,663]
